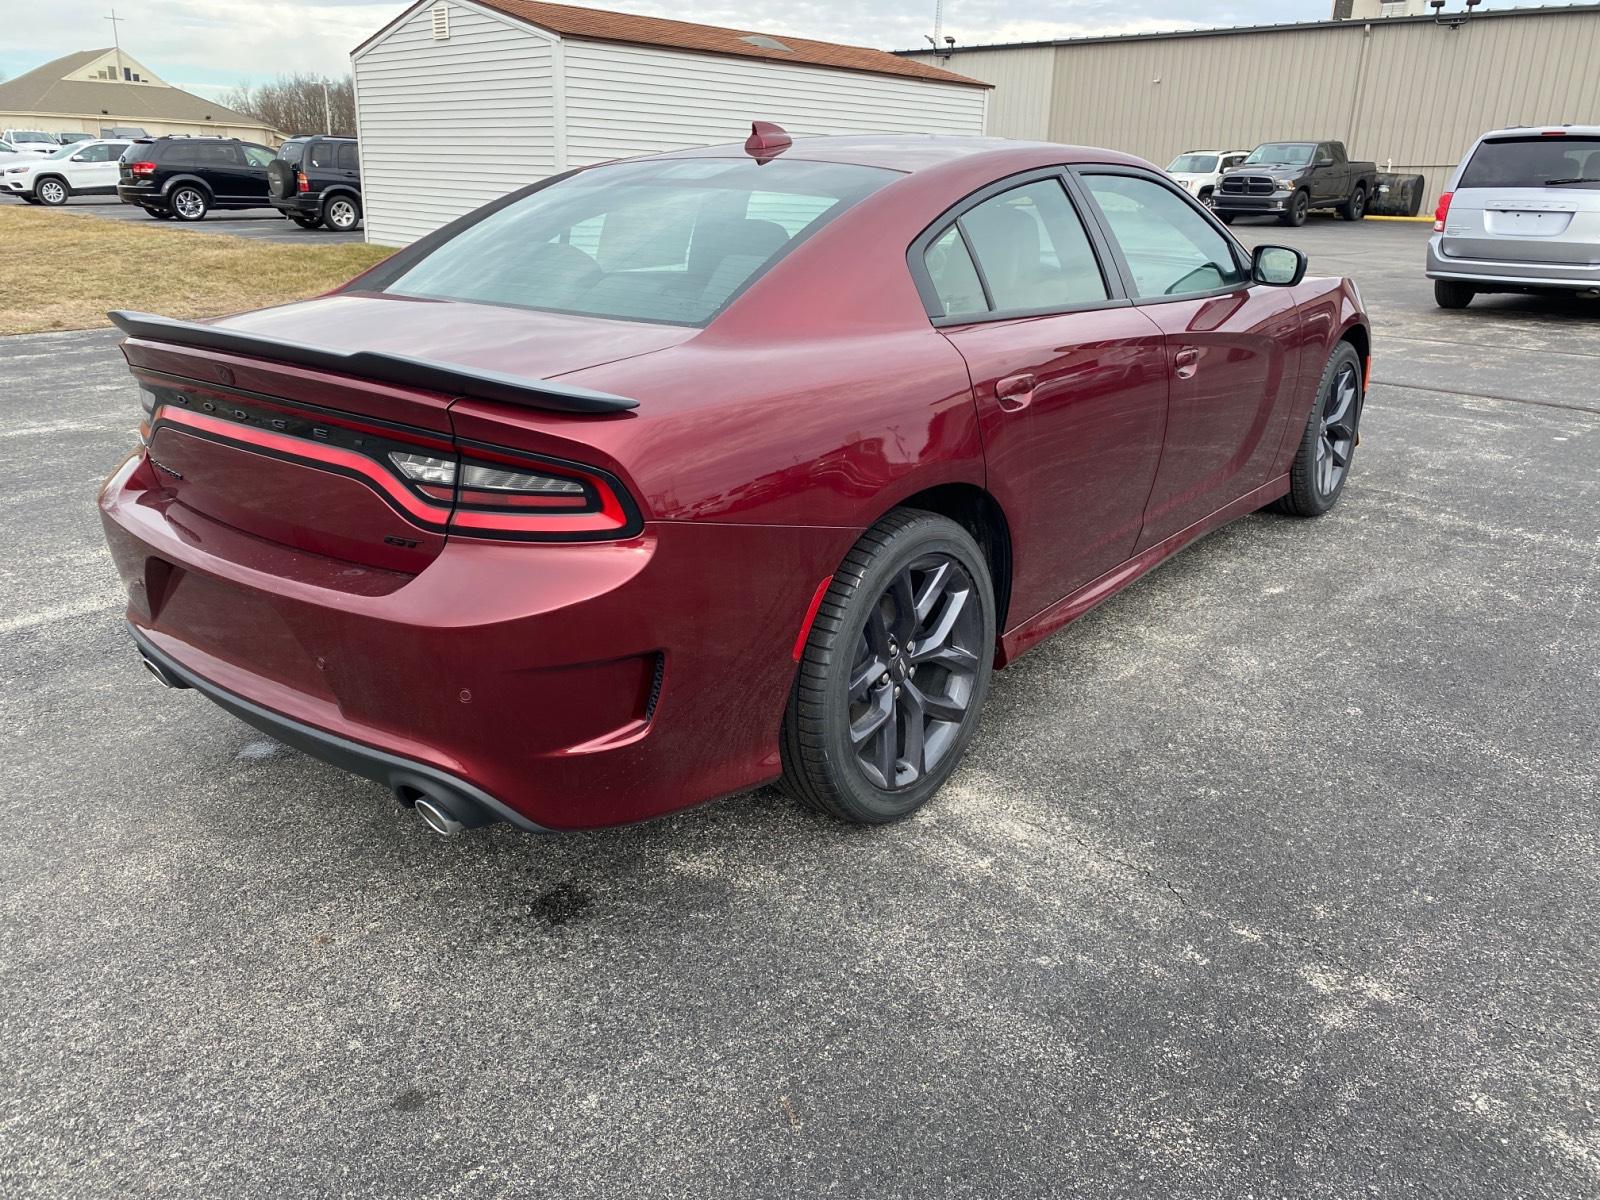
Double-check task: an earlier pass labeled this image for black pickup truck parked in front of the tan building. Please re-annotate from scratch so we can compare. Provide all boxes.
[1211,142,1378,226]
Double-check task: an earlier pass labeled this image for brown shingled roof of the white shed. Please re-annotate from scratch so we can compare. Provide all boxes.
[460,0,994,88]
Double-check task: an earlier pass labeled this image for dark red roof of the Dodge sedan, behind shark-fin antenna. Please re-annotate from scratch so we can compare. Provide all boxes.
[636,133,1149,174]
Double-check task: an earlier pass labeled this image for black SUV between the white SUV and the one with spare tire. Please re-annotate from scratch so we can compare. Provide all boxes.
[117,138,272,221]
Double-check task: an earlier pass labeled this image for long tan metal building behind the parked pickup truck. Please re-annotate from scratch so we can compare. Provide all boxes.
[907,5,1600,208]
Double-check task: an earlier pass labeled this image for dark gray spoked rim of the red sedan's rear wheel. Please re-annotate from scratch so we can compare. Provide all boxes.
[846,554,984,792]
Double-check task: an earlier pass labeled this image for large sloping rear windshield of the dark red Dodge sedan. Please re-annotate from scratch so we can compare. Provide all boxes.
[382,158,898,325]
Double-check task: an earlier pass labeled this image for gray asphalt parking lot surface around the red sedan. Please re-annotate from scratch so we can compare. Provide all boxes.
[0,221,1600,1198]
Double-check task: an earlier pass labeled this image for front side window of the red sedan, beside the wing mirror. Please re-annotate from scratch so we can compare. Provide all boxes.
[1083,174,1245,299]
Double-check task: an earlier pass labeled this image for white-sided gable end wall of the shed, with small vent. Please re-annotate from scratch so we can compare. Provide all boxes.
[352,3,560,246]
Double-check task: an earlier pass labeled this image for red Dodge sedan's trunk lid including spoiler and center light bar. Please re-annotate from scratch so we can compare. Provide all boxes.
[114,298,694,574]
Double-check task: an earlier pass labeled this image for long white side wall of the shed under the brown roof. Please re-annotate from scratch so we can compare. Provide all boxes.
[563,38,987,166]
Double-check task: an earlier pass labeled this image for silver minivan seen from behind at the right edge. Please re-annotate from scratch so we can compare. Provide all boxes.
[1427,125,1600,309]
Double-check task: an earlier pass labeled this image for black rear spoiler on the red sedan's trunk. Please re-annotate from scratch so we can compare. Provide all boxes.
[106,310,638,413]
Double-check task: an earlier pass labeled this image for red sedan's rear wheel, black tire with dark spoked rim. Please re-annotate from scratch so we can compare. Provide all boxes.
[781,509,995,826]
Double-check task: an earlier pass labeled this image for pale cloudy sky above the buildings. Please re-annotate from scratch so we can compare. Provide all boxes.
[0,0,1576,98]
